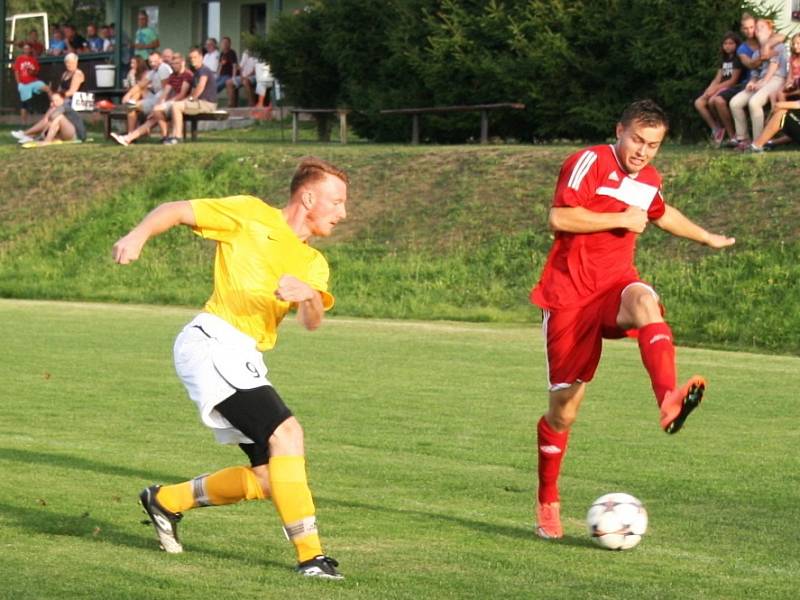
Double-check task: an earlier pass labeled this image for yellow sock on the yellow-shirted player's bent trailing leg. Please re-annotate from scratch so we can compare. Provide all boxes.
[156,467,264,512]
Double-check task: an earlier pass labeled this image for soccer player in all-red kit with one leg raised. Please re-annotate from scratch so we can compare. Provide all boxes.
[531,100,735,538]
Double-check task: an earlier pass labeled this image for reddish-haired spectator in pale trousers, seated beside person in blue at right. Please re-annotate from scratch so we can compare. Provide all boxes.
[730,19,787,150]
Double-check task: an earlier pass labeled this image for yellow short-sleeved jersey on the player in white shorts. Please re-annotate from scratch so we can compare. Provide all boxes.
[190,196,334,351]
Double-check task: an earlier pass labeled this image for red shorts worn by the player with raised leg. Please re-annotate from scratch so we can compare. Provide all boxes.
[542,280,658,392]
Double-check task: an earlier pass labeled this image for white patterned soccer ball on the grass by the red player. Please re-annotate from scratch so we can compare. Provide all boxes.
[586,493,647,550]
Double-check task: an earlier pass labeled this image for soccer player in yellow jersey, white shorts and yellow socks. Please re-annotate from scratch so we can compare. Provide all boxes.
[113,157,349,579]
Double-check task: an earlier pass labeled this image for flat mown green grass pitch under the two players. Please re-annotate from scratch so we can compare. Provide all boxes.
[0,300,800,600]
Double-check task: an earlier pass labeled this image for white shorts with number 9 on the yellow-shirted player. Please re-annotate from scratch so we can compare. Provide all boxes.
[173,313,272,444]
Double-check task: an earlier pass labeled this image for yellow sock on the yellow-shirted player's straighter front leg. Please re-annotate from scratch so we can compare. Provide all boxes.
[269,456,322,562]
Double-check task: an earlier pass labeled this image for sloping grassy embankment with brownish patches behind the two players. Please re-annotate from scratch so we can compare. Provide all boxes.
[0,126,800,354]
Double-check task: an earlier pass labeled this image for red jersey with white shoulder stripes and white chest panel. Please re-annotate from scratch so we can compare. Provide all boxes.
[531,145,666,310]
